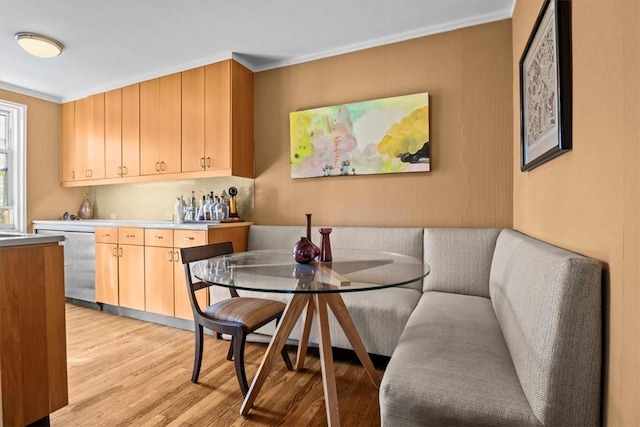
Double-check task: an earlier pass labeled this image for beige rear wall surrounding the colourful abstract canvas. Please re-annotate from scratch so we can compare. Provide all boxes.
[254,20,513,227]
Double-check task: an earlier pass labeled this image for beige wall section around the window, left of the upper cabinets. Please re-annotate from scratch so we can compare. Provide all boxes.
[0,89,86,230]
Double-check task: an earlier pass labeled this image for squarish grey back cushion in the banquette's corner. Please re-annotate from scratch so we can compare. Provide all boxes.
[423,228,500,298]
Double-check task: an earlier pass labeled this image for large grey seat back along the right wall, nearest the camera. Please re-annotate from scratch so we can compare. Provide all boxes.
[489,229,602,426]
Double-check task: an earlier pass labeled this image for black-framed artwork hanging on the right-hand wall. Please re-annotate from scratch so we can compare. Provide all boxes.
[519,0,572,172]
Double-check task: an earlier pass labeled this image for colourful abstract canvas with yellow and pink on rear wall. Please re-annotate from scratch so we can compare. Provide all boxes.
[289,92,430,178]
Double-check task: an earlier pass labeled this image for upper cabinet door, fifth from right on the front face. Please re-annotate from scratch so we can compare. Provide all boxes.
[122,84,140,176]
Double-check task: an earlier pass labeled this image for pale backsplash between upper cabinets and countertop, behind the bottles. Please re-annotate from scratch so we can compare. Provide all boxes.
[89,177,254,221]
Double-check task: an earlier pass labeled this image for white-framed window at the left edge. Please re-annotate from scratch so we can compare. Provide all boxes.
[0,101,27,232]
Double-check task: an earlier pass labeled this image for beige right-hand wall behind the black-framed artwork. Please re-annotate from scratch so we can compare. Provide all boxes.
[513,0,640,426]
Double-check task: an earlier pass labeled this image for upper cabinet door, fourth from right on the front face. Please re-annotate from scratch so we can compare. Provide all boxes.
[140,79,160,175]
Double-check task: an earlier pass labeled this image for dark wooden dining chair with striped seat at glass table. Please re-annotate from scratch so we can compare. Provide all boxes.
[180,242,293,395]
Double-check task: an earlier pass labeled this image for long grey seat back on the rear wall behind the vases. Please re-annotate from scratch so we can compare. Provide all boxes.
[248,225,423,290]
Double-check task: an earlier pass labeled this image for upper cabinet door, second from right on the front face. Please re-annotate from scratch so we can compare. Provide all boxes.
[182,67,205,172]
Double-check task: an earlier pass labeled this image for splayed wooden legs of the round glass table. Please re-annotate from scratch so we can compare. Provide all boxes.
[240,293,382,426]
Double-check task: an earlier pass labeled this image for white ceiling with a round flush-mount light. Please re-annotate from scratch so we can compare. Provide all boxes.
[0,0,514,102]
